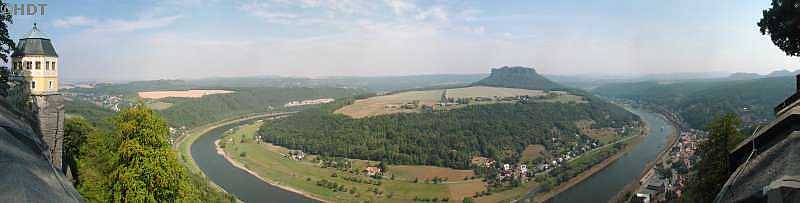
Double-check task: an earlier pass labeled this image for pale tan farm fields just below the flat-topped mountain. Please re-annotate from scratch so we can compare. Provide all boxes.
[334,86,586,118]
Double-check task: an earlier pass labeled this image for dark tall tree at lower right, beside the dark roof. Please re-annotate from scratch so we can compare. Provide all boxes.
[688,113,741,202]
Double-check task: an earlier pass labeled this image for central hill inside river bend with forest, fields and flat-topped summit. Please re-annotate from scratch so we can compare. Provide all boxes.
[259,67,639,169]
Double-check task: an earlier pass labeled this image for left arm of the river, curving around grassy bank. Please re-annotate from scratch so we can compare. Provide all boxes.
[191,118,316,202]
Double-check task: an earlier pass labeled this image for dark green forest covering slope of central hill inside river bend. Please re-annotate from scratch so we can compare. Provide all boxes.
[258,97,639,169]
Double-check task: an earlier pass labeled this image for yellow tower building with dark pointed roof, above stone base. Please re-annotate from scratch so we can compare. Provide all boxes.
[11,23,59,95]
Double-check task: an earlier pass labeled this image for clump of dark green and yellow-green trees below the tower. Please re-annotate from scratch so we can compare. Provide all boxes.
[64,103,216,202]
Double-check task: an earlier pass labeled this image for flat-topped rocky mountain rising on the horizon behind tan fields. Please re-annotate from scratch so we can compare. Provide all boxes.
[472,67,564,90]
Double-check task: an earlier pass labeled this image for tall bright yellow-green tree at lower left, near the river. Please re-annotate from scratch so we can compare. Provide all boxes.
[109,103,192,202]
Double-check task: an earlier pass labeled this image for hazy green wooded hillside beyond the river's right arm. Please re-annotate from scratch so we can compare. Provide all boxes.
[592,77,795,129]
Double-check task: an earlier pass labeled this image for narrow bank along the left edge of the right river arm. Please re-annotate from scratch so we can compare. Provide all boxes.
[533,131,649,202]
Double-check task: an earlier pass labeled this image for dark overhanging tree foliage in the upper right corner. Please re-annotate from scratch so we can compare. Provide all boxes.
[758,0,800,56]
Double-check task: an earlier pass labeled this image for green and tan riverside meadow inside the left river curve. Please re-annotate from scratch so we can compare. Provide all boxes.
[220,122,486,202]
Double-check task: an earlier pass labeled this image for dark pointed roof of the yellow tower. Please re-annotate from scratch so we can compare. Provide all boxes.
[11,23,58,57]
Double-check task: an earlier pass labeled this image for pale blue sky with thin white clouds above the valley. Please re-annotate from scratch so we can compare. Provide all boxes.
[10,0,800,81]
